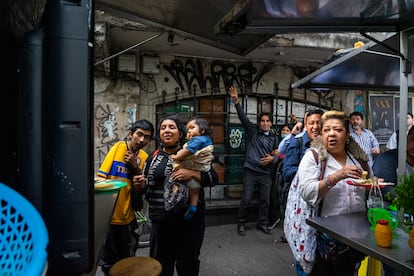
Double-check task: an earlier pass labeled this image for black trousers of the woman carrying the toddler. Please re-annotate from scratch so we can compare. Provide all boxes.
[150,213,205,276]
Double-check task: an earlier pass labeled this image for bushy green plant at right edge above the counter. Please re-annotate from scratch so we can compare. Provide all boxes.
[393,173,414,233]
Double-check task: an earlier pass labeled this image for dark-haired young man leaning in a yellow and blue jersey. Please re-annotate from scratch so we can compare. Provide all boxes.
[97,120,154,275]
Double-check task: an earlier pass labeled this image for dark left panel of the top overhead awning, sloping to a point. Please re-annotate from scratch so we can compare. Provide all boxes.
[96,0,273,56]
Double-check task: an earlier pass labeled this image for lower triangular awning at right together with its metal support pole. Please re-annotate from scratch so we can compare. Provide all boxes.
[292,31,414,179]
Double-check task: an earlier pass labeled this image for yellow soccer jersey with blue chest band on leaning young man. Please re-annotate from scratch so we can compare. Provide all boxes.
[97,141,148,225]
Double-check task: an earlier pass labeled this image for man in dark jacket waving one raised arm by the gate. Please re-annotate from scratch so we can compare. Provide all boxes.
[229,86,279,236]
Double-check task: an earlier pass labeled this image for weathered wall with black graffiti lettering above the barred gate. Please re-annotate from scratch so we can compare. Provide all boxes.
[94,54,341,175]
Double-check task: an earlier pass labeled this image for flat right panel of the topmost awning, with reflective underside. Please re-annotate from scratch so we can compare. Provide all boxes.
[216,0,414,34]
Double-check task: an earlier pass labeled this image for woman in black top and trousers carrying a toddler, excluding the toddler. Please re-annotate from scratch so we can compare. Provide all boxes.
[134,116,217,276]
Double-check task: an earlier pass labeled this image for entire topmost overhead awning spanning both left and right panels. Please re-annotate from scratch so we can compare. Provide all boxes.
[95,0,414,56]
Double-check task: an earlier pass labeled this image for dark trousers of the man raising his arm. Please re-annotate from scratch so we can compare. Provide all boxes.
[237,168,272,226]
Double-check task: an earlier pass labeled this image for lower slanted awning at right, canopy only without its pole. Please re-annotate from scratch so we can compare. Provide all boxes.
[292,35,414,91]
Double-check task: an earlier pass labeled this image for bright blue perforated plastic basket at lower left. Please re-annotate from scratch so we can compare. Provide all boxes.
[0,183,49,275]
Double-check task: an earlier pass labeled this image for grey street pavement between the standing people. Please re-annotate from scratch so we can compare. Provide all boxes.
[96,210,295,276]
